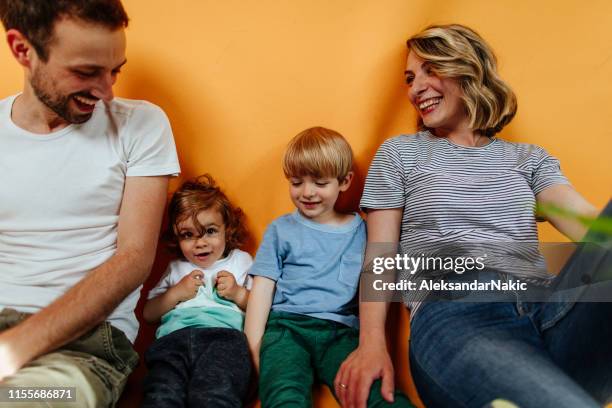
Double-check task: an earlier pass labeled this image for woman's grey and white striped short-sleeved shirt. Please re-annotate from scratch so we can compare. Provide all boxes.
[360,131,569,316]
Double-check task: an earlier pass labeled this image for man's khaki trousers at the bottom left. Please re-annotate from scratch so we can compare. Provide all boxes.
[0,309,138,408]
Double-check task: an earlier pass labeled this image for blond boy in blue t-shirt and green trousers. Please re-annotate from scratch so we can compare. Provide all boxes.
[245,127,412,408]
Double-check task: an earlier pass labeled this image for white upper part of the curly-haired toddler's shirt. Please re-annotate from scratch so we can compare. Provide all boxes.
[147,249,253,308]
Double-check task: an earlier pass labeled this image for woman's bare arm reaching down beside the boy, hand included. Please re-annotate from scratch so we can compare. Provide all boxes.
[334,208,403,408]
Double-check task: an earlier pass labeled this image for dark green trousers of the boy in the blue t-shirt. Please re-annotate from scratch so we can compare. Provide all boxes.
[259,312,413,408]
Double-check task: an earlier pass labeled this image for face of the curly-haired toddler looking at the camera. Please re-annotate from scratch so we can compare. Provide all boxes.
[176,208,225,268]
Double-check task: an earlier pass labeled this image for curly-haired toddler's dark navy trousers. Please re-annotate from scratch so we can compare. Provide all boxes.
[142,328,251,408]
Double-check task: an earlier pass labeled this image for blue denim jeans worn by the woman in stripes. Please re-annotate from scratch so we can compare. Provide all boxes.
[410,205,612,408]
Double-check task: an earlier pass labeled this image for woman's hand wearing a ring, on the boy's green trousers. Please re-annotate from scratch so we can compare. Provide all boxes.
[334,343,395,408]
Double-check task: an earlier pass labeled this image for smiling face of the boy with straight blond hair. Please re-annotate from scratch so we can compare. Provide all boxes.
[289,172,353,224]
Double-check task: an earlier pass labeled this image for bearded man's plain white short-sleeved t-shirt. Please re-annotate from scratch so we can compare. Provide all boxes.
[0,96,180,341]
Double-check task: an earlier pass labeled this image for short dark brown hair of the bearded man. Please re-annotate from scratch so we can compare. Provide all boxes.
[0,0,129,61]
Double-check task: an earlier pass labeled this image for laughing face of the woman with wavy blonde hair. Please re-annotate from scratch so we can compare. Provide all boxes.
[405,52,469,136]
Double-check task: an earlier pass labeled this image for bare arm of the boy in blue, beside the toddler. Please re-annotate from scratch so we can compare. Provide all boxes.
[244,276,276,372]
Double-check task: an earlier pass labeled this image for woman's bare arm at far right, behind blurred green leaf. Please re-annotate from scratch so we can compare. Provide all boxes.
[536,184,597,241]
